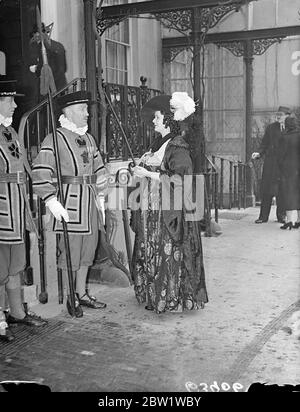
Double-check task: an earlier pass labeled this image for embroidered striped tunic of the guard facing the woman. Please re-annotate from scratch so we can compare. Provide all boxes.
[33,127,106,235]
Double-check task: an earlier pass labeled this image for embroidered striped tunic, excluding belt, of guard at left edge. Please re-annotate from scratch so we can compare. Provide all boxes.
[0,124,25,244]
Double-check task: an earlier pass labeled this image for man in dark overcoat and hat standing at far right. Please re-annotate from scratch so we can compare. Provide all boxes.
[252,106,291,223]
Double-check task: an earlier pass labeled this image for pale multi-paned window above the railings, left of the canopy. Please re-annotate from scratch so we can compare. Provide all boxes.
[103,0,130,84]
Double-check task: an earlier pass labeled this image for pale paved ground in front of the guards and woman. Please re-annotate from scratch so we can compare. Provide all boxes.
[0,208,300,392]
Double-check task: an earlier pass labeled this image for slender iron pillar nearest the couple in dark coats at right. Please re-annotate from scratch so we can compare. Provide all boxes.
[244,40,255,207]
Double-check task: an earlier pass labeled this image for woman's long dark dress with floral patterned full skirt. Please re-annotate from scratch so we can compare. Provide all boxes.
[133,136,208,313]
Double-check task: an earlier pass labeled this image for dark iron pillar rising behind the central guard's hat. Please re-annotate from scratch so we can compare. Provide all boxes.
[83,0,100,140]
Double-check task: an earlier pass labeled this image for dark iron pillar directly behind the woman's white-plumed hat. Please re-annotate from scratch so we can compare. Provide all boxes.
[192,7,205,173]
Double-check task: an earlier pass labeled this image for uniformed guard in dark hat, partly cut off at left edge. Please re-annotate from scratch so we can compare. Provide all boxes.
[0,78,47,342]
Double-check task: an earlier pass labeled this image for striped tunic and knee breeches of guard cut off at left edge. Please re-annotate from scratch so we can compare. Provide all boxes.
[0,124,37,285]
